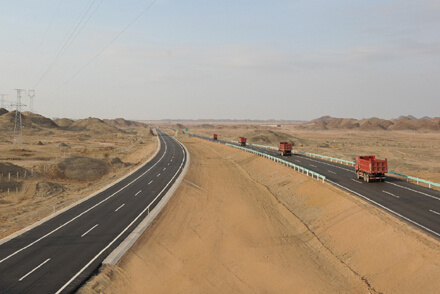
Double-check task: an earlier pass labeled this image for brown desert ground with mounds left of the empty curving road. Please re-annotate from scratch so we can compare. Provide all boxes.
[0,111,157,238]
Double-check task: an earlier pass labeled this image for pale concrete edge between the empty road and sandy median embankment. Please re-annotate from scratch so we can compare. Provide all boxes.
[102,139,190,265]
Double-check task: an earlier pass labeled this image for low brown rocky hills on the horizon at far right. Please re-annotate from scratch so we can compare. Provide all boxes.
[298,115,440,131]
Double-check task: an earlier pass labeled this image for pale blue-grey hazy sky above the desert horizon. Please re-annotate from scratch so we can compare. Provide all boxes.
[0,0,440,120]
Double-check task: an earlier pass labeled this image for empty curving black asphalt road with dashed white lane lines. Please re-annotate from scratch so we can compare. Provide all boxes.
[0,131,187,293]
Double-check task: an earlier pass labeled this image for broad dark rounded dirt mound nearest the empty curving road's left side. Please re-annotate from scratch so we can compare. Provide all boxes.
[48,157,109,181]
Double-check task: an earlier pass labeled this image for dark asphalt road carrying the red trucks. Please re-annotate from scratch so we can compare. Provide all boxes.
[192,136,440,238]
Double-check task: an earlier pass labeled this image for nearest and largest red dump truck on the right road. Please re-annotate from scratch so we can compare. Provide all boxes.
[354,155,388,183]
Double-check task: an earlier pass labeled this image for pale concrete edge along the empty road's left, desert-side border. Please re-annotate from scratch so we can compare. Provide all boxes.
[0,131,161,245]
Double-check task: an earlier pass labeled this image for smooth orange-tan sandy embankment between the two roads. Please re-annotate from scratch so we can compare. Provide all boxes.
[80,139,440,293]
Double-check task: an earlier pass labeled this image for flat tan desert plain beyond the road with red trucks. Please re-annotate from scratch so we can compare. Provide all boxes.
[162,122,440,183]
